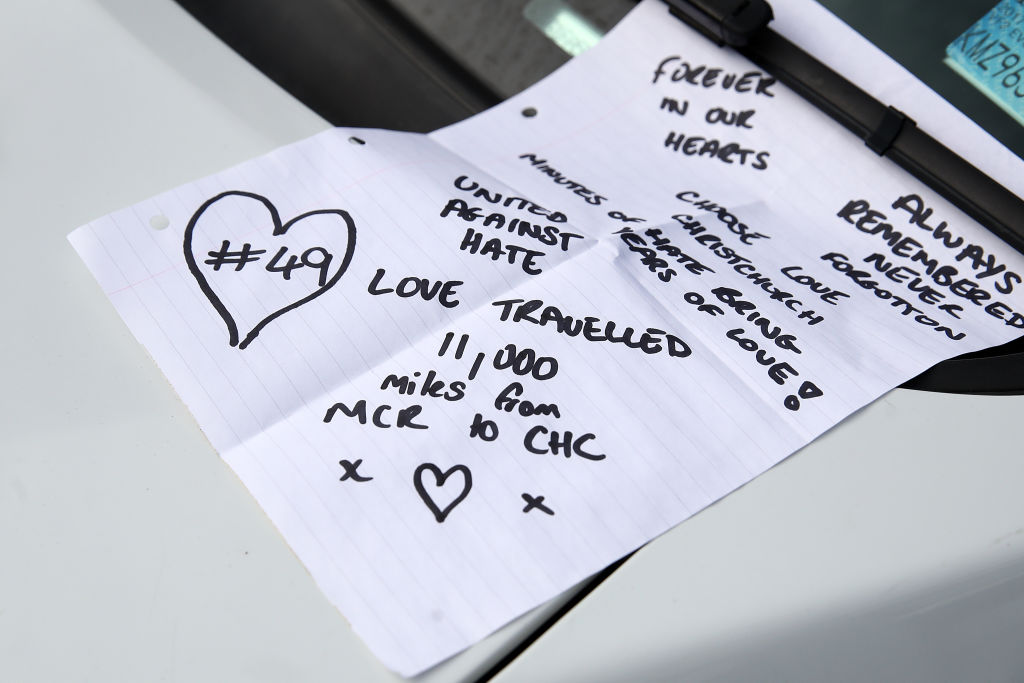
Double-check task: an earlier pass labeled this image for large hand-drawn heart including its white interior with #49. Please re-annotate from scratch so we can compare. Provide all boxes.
[183,190,355,349]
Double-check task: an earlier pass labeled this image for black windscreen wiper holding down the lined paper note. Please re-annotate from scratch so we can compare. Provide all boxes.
[665,0,1024,254]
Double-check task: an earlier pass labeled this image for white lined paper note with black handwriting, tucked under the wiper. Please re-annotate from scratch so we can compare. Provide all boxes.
[71,2,1024,675]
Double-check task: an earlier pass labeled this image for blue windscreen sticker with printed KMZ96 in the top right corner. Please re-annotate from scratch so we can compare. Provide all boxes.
[945,0,1024,124]
